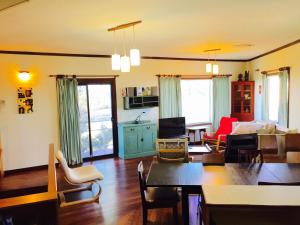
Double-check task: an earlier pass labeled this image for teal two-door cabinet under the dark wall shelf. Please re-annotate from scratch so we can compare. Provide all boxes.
[118,121,157,159]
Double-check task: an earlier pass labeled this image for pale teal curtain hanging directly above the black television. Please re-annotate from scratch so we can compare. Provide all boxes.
[159,77,182,118]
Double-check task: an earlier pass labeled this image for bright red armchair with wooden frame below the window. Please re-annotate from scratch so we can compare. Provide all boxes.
[202,117,238,151]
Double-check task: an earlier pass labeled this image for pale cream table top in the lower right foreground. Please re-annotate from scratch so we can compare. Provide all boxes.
[202,185,300,206]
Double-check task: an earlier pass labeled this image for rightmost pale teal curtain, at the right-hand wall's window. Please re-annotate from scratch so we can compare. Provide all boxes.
[278,70,289,127]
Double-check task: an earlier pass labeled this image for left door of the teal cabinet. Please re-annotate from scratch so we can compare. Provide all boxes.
[124,127,139,154]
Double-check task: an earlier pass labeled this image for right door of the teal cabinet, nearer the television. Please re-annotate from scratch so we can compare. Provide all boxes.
[141,125,156,152]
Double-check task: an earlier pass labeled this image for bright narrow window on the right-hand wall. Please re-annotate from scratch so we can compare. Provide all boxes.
[267,75,279,122]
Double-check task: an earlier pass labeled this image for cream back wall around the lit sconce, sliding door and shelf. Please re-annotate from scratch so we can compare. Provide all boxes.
[0,54,245,170]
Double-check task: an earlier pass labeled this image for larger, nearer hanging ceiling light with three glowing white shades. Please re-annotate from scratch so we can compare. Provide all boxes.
[108,20,142,72]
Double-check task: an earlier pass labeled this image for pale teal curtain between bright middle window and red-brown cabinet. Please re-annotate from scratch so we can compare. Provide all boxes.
[213,77,230,131]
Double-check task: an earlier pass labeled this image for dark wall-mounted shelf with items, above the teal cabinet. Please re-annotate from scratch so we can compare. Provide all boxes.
[123,87,159,109]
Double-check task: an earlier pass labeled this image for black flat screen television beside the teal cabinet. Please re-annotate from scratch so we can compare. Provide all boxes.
[158,117,185,138]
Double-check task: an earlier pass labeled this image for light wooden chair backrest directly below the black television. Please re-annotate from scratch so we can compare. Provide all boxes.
[156,138,189,162]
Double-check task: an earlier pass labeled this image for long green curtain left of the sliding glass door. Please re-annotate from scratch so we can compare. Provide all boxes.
[56,78,82,165]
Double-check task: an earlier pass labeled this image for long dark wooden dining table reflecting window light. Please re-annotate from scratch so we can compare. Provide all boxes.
[146,162,300,225]
